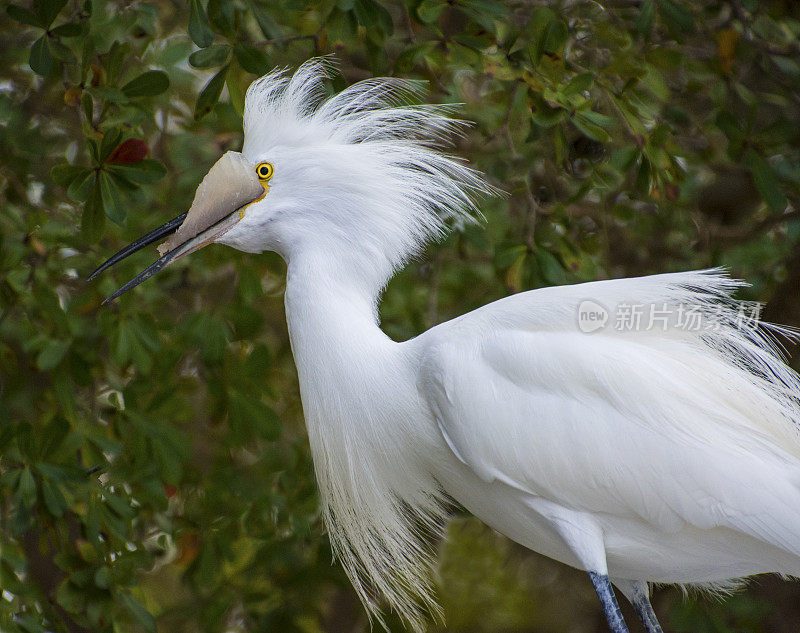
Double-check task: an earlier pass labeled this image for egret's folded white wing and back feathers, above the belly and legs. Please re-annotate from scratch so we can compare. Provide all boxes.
[418,271,800,582]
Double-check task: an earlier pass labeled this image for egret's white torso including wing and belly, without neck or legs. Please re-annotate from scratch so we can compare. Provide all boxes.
[414,272,800,584]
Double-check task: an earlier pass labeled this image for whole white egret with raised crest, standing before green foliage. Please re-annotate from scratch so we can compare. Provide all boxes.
[89,60,800,633]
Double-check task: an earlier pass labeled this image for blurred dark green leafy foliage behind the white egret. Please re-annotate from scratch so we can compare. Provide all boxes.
[0,0,800,633]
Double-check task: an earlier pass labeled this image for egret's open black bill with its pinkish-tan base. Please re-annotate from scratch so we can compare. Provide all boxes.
[89,152,269,305]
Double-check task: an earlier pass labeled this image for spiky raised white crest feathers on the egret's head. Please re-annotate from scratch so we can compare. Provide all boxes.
[242,58,496,281]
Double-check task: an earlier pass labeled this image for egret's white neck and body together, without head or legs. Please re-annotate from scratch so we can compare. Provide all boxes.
[286,254,800,624]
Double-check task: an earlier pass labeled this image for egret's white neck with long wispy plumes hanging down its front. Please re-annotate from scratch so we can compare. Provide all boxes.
[286,251,446,630]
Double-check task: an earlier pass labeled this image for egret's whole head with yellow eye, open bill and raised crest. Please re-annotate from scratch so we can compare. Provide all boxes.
[90,58,491,300]
